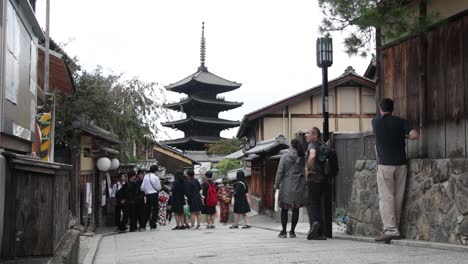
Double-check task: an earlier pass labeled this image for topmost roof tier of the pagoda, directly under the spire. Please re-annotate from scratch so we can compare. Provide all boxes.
[165,67,242,94]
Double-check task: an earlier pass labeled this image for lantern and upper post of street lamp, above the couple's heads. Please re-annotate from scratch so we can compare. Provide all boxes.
[317,37,333,142]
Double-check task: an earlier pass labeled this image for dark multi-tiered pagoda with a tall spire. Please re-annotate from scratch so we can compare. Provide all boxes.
[162,22,242,150]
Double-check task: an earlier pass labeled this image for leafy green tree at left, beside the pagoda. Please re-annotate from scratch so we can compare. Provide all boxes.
[56,68,167,162]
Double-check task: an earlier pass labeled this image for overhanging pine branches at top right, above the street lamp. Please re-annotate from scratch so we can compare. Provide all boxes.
[319,0,437,56]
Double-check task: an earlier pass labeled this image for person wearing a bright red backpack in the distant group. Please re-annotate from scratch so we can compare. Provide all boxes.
[202,171,218,229]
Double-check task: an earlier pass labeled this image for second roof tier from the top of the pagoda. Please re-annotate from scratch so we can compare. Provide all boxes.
[164,96,243,112]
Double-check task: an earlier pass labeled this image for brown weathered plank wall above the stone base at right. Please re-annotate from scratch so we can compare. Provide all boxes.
[379,12,468,158]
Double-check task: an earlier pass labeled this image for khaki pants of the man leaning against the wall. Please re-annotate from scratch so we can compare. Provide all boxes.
[377,165,407,236]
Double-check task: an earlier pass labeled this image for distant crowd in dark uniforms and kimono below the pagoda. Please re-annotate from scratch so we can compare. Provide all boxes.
[113,165,254,232]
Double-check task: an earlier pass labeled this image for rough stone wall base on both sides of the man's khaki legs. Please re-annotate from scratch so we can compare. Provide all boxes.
[347,159,468,245]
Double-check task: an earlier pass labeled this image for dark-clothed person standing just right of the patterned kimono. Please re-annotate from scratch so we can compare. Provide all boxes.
[171,171,185,230]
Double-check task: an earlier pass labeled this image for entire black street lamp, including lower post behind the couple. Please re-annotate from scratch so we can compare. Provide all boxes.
[317,37,334,238]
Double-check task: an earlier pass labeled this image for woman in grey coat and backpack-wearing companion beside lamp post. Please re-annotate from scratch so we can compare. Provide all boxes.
[274,127,329,240]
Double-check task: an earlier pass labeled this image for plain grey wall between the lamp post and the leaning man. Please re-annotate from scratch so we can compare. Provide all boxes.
[333,131,375,208]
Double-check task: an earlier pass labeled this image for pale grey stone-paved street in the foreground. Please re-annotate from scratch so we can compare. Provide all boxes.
[94,217,468,264]
